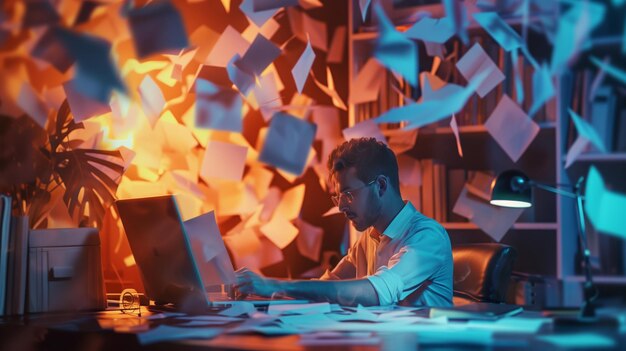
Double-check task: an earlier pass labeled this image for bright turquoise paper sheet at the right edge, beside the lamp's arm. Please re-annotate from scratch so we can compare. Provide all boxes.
[584,166,626,238]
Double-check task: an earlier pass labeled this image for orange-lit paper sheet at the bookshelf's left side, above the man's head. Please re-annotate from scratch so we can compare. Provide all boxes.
[348,58,385,104]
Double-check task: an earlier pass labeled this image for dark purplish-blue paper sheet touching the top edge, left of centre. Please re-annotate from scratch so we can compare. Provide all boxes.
[128,1,189,58]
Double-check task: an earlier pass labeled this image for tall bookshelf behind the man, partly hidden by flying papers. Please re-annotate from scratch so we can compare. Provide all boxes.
[347,1,626,305]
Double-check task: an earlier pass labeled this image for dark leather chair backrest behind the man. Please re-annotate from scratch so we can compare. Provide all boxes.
[452,243,517,303]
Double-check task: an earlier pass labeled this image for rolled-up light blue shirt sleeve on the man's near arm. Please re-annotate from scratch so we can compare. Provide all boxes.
[367,228,448,305]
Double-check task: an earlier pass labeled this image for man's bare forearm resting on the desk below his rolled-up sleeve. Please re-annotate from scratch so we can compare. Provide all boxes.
[275,279,378,306]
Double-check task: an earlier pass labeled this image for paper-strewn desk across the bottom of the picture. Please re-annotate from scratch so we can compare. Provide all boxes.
[0,311,626,351]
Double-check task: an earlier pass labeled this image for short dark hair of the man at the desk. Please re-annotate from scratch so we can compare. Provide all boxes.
[328,138,400,193]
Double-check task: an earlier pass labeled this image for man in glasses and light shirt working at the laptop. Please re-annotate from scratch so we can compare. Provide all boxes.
[237,138,452,306]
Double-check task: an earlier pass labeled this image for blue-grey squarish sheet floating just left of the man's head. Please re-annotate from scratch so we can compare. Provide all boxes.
[259,112,317,175]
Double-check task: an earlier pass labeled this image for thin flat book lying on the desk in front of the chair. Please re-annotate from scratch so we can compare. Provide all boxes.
[429,302,524,320]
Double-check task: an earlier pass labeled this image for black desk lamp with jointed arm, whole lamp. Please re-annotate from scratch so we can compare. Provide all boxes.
[490,170,598,319]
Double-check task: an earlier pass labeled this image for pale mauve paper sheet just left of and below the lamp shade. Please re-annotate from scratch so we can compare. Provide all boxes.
[452,187,524,242]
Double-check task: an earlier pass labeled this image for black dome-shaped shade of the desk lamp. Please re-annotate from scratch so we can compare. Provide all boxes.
[490,170,532,208]
